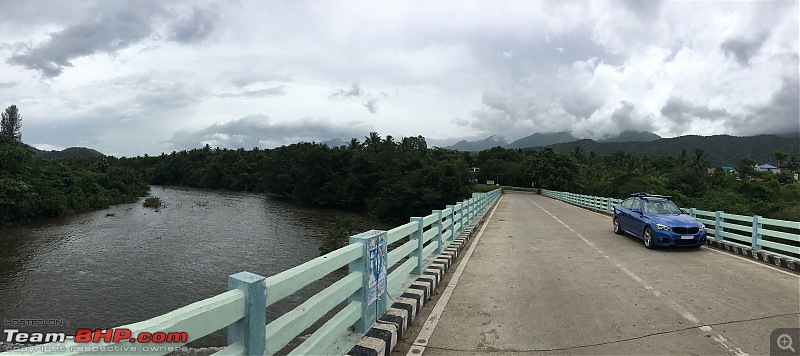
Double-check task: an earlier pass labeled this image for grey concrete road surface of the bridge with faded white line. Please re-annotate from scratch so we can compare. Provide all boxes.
[410,192,800,355]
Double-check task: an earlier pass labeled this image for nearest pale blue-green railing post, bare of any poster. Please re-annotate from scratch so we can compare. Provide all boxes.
[228,272,267,355]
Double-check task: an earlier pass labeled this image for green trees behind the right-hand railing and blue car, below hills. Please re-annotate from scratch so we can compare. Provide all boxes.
[465,147,800,221]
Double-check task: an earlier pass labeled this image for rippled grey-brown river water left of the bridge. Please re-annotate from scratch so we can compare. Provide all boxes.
[0,187,385,347]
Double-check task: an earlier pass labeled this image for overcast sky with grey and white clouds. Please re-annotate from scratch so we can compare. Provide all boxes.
[0,0,800,156]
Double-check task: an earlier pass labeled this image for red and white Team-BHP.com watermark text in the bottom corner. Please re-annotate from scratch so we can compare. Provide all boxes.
[3,328,189,352]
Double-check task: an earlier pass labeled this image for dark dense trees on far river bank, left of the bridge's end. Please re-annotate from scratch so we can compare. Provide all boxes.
[114,132,470,223]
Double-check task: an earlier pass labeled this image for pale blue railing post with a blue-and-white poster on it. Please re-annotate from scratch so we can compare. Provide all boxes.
[348,230,386,333]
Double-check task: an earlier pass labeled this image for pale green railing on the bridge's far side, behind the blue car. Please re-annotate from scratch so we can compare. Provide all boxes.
[542,189,800,258]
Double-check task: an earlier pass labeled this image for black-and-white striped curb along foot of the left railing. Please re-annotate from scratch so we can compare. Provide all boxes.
[347,197,499,356]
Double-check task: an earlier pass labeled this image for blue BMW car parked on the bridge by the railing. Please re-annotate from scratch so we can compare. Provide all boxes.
[614,193,706,249]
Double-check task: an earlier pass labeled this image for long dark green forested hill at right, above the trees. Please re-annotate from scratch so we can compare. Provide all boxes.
[549,135,800,166]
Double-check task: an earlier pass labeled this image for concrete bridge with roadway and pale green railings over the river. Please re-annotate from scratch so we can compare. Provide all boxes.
[4,189,800,355]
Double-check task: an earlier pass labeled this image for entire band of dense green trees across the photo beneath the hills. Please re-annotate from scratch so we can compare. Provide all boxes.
[0,101,800,230]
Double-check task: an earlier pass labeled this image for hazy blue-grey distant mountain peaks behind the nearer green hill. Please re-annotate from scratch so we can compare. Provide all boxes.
[446,131,661,152]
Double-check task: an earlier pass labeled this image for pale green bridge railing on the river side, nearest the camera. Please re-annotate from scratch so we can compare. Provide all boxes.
[0,189,502,355]
